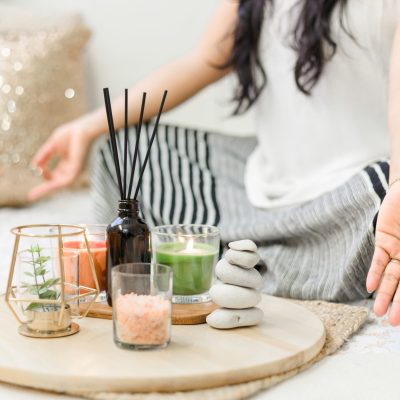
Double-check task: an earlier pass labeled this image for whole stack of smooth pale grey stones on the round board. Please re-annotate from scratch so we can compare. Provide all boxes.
[207,240,264,329]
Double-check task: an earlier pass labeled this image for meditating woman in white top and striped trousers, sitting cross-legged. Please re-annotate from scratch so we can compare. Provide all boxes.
[31,0,400,325]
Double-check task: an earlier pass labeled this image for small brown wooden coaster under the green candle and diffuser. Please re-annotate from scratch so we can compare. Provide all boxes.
[88,301,218,325]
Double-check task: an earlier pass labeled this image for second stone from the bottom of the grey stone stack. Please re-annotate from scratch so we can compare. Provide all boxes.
[210,283,261,309]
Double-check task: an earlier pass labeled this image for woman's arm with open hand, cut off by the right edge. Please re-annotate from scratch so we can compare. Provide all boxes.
[367,26,400,325]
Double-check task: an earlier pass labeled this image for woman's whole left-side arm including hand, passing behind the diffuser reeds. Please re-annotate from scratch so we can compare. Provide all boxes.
[29,0,238,200]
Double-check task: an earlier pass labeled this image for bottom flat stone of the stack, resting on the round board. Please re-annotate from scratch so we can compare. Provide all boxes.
[207,308,264,329]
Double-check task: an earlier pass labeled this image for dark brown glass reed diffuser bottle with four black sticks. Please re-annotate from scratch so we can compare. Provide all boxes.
[104,88,168,306]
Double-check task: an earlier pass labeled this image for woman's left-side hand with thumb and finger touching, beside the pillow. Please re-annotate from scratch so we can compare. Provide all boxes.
[28,120,91,201]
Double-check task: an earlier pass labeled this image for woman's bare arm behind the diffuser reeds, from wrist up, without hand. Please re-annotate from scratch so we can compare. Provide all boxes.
[85,0,237,142]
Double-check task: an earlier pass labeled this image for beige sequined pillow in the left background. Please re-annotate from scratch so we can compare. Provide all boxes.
[0,6,90,206]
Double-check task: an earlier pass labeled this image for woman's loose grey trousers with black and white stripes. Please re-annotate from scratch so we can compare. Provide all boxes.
[92,125,389,301]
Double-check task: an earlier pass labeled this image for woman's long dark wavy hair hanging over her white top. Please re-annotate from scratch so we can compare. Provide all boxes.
[224,0,347,115]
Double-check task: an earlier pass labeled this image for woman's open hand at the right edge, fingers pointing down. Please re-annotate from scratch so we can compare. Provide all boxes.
[367,182,400,326]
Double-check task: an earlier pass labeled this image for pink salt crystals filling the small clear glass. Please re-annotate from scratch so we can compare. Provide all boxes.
[115,293,170,345]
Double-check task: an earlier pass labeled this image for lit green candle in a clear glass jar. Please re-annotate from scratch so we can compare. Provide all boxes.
[151,225,220,304]
